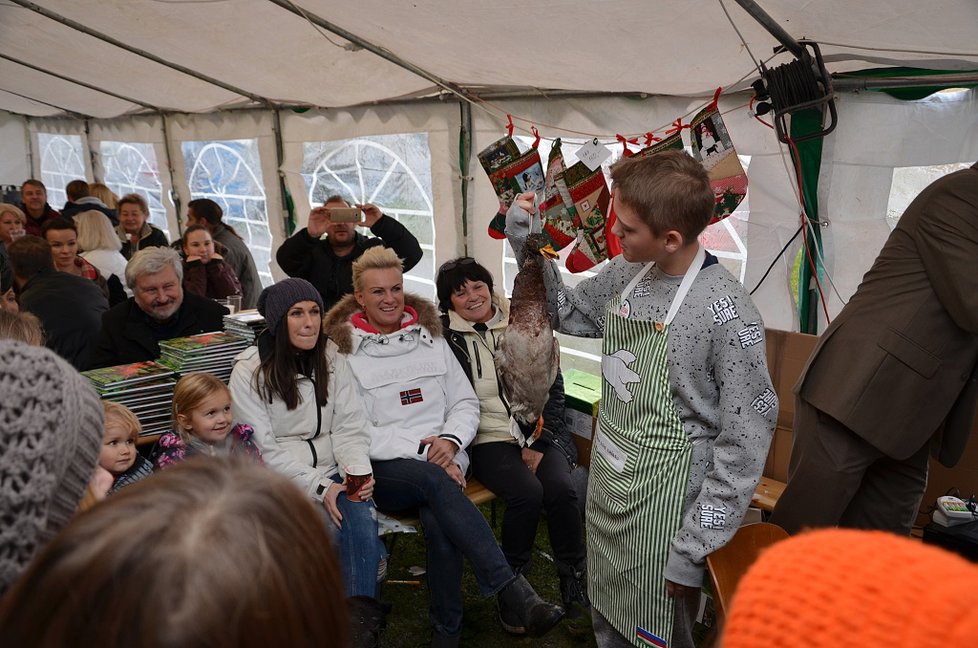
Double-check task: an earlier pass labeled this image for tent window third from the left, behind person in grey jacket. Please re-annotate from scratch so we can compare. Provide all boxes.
[182,139,274,286]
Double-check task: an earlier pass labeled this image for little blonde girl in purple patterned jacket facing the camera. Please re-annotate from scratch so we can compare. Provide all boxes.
[152,373,263,469]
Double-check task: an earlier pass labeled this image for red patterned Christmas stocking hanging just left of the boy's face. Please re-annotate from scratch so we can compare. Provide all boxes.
[564,162,611,272]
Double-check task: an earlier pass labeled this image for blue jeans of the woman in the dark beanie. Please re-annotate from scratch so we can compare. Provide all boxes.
[319,475,387,598]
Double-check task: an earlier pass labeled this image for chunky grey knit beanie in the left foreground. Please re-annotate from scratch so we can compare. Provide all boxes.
[0,340,104,595]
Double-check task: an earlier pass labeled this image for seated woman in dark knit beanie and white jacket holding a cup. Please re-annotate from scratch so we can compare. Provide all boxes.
[229,279,386,644]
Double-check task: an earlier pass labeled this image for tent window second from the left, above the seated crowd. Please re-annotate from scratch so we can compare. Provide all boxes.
[99,141,170,239]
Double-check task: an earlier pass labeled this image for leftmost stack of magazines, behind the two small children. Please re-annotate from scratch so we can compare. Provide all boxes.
[82,362,177,437]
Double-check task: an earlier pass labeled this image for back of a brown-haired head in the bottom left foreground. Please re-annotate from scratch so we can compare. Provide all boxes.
[0,458,350,648]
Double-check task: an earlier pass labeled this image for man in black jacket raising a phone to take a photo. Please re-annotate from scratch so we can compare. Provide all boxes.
[275,196,422,310]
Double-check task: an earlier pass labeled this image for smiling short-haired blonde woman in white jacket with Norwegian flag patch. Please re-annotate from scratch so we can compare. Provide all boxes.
[324,247,563,648]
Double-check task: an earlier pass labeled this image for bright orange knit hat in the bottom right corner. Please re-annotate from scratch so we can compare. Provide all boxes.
[722,529,978,648]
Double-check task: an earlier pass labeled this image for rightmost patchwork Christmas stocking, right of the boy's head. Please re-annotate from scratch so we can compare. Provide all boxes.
[690,91,747,224]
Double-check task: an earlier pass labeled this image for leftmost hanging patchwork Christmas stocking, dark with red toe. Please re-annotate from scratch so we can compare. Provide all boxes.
[479,136,543,239]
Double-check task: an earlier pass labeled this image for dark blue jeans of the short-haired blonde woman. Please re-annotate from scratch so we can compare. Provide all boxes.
[371,459,514,636]
